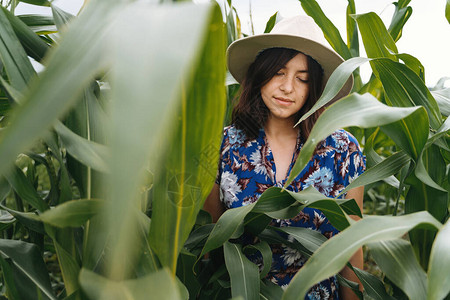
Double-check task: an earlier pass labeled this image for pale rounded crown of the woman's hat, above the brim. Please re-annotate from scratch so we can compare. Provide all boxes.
[270,16,329,48]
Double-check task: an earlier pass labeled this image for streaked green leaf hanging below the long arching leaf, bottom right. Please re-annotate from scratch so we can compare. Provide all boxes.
[368,239,427,300]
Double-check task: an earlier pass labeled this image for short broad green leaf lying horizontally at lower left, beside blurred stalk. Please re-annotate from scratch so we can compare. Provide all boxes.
[39,199,105,228]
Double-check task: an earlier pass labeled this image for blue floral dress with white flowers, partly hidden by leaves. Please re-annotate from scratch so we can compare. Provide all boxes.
[216,125,365,299]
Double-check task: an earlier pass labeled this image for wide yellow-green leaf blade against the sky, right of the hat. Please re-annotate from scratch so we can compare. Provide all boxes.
[354,12,398,60]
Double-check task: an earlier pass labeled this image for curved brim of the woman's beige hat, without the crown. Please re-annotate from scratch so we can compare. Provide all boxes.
[227,33,353,104]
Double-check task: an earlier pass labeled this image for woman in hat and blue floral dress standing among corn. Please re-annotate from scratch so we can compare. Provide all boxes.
[204,16,365,299]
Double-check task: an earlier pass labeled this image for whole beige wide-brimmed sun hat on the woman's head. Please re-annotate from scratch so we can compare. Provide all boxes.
[227,16,353,102]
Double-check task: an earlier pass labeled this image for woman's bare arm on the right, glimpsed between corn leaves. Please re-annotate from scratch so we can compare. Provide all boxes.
[340,186,364,300]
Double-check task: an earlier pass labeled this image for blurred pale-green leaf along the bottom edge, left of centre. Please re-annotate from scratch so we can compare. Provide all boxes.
[80,269,182,300]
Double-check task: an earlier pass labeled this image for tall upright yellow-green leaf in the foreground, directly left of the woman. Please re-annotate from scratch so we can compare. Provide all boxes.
[145,2,226,272]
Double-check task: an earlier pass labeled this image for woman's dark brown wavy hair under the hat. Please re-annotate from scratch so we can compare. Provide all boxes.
[231,48,323,142]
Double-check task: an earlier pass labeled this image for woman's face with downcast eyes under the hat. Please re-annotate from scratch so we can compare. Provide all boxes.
[261,53,309,122]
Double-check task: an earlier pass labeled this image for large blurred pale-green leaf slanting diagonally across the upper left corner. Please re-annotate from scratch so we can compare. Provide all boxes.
[0,1,114,178]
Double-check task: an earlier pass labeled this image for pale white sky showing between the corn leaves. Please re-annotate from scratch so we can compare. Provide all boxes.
[16,0,450,87]
